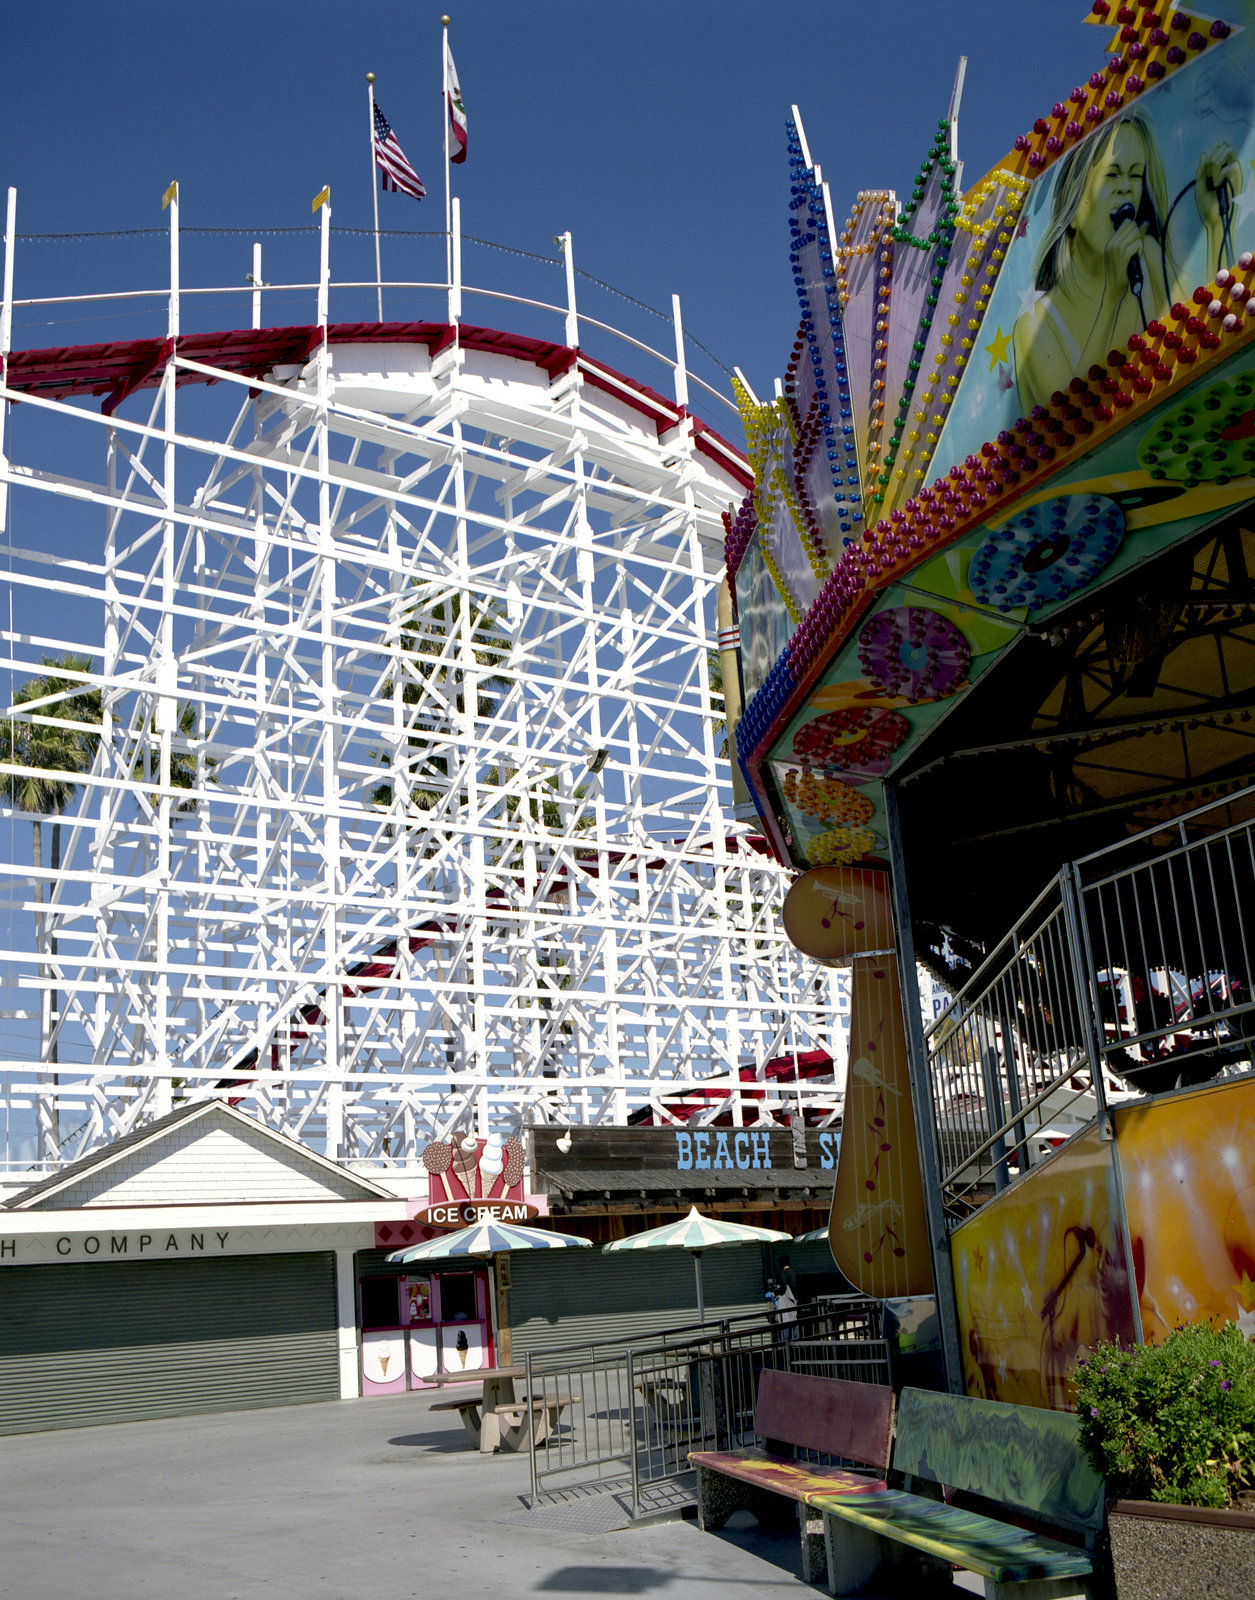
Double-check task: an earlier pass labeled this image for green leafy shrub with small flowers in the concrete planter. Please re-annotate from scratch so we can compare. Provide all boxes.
[1074,1323,1255,1506]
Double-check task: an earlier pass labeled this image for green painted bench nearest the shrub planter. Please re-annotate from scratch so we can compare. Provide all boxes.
[807,1389,1103,1600]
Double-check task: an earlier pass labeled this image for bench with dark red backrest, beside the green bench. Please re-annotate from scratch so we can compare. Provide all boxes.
[688,1368,893,1582]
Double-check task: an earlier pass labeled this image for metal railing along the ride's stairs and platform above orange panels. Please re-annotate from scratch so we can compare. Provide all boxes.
[925,789,1255,1224]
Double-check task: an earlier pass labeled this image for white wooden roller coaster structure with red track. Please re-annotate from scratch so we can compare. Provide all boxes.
[0,194,839,1166]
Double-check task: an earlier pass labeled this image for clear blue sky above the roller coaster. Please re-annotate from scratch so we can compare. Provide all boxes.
[0,0,1109,412]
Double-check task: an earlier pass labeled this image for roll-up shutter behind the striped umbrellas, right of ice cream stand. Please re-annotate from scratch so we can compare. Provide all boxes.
[509,1245,767,1360]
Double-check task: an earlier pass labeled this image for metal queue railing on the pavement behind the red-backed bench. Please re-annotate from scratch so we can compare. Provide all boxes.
[525,1299,888,1517]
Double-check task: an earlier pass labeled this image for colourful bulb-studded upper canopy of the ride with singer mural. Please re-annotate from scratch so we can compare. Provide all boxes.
[728,0,1255,869]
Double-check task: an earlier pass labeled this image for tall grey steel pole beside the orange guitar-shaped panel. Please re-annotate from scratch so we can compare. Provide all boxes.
[884,784,964,1394]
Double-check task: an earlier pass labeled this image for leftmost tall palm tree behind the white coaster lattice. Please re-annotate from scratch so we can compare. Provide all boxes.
[0,656,102,1154]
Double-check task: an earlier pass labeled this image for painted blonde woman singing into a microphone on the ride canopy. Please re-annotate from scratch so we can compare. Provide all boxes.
[1012,110,1242,410]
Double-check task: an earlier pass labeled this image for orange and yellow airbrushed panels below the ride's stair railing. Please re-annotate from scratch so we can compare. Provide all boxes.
[951,1077,1255,1410]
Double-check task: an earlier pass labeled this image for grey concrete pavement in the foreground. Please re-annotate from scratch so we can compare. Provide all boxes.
[0,1395,823,1600]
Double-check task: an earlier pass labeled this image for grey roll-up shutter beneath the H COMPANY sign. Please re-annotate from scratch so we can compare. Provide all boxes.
[0,1251,339,1434]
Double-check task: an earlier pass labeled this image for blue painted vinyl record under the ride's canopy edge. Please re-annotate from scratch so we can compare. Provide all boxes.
[968,494,1124,611]
